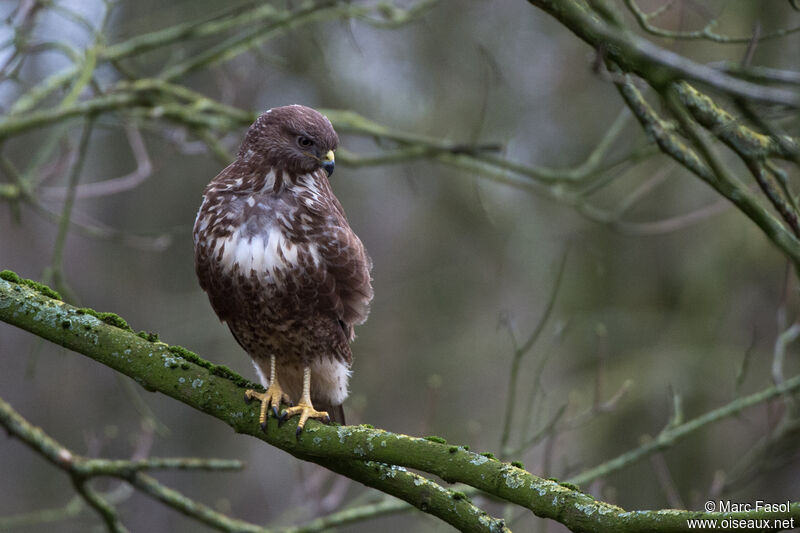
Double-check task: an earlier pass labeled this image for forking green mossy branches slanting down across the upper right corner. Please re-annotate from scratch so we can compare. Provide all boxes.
[529,0,800,264]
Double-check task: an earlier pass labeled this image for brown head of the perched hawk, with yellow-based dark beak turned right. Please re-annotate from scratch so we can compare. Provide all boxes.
[239,105,339,176]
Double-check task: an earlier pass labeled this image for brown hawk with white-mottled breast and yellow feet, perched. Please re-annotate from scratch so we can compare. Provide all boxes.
[193,105,372,435]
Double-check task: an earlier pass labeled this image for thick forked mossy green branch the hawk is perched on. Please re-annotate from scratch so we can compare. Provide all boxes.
[0,271,800,531]
